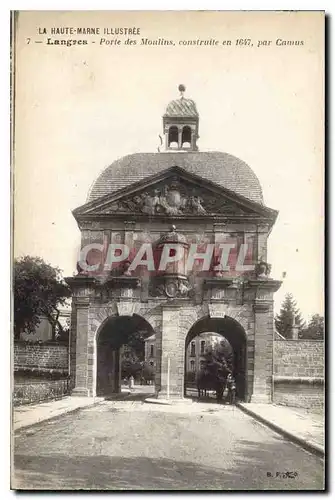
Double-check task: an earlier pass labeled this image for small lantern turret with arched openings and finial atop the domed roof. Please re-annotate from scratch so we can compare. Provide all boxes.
[163,84,199,152]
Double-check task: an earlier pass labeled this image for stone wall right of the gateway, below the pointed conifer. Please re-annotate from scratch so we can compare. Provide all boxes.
[273,340,324,409]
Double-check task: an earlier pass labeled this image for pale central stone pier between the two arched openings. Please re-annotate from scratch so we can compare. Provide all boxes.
[158,304,184,399]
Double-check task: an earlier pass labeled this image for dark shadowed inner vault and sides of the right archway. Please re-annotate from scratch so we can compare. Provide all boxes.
[184,316,249,403]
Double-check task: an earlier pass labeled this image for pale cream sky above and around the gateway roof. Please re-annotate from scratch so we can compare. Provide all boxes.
[14,11,324,319]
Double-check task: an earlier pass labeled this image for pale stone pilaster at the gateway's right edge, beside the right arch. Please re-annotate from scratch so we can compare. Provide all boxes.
[251,302,273,403]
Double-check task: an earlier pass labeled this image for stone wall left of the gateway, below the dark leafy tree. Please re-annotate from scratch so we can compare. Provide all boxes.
[14,342,69,371]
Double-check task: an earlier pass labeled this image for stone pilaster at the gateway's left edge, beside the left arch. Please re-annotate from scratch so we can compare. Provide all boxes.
[72,297,89,396]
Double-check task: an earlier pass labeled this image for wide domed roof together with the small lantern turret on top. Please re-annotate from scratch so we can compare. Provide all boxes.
[87,85,263,204]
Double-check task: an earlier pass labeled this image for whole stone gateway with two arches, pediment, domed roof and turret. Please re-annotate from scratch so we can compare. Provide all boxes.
[67,85,281,403]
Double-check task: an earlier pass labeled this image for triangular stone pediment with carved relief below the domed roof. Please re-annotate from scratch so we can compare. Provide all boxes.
[73,167,277,219]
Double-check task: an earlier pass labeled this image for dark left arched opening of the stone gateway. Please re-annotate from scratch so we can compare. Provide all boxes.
[96,314,155,396]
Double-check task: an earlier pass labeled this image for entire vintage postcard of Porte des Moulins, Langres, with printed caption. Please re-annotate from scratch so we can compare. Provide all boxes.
[11,11,325,492]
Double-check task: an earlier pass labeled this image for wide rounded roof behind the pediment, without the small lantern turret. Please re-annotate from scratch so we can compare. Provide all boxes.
[87,151,263,204]
